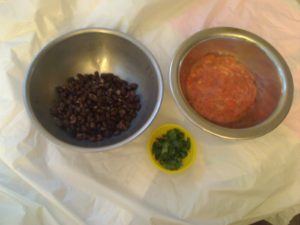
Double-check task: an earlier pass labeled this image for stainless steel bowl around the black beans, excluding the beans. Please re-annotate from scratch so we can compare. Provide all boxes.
[24,29,163,151]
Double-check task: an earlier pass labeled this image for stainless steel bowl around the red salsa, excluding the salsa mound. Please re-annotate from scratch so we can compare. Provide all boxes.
[169,27,293,139]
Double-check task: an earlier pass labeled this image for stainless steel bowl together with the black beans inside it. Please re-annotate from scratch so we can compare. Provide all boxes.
[24,29,163,151]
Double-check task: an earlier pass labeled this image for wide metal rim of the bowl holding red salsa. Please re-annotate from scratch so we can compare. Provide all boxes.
[169,27,294,139]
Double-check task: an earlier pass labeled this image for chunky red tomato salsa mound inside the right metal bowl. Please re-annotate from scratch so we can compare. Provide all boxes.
[181,53,257,125]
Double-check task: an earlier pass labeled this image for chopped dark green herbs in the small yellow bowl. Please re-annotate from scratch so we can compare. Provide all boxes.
[152,128,191,170]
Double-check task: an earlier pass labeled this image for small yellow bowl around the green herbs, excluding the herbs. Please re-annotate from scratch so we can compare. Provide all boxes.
[147,124,197,174]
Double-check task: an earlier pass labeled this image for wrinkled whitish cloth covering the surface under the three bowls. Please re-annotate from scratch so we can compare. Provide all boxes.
[0,0,300,225]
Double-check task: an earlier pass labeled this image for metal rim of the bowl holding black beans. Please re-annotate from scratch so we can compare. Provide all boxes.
[22,28,164,152]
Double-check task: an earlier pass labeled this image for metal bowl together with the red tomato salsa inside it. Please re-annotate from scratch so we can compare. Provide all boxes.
[169,27,293,139]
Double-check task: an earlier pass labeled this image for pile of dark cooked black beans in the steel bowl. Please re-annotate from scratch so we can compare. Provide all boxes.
[51,72,141,141]
